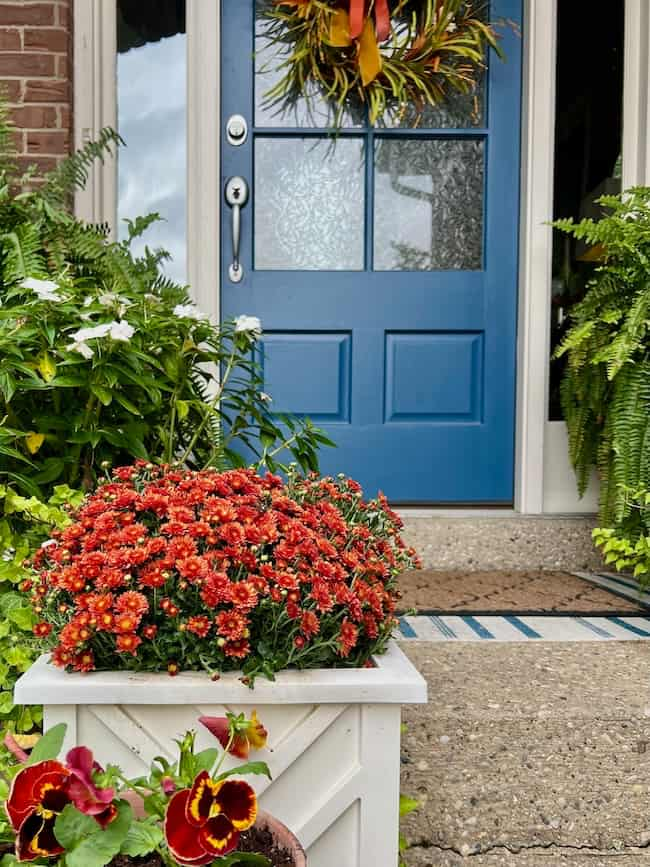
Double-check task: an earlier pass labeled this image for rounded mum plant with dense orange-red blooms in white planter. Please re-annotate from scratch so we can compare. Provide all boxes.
[25,462,417,683]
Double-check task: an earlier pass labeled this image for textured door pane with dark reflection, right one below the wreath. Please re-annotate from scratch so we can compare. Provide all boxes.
[374,139,484,271]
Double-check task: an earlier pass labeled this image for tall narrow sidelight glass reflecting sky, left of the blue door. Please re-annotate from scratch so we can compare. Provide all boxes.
[117,0,187,282]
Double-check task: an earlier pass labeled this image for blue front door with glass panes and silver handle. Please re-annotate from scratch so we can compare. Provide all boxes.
[221,0,521,504]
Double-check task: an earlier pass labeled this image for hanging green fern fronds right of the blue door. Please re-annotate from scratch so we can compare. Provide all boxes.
[554,187,650,526]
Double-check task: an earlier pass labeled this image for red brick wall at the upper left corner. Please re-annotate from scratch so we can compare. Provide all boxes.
[0,0,73,178]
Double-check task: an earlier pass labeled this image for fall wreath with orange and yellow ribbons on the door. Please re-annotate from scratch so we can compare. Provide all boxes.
[263,0,502,124]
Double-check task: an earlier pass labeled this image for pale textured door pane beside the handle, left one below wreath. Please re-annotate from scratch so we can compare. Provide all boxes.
[255,138,365,271]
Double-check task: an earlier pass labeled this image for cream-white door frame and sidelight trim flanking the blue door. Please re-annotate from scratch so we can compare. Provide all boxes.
[74,0,650,514]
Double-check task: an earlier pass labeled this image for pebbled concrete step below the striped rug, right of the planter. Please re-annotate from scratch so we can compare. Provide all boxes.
[402,641,650,867]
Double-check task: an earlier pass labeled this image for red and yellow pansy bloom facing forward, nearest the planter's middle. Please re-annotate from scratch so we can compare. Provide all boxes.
[165,771,257,865]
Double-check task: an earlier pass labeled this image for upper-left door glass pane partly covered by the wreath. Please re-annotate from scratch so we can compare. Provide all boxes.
[255,8,365,129]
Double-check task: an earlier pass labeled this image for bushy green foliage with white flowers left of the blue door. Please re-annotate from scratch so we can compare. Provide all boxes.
[0,90,329,497]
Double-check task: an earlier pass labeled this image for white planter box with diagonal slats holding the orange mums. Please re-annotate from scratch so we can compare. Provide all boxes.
[14,642,427,867]
